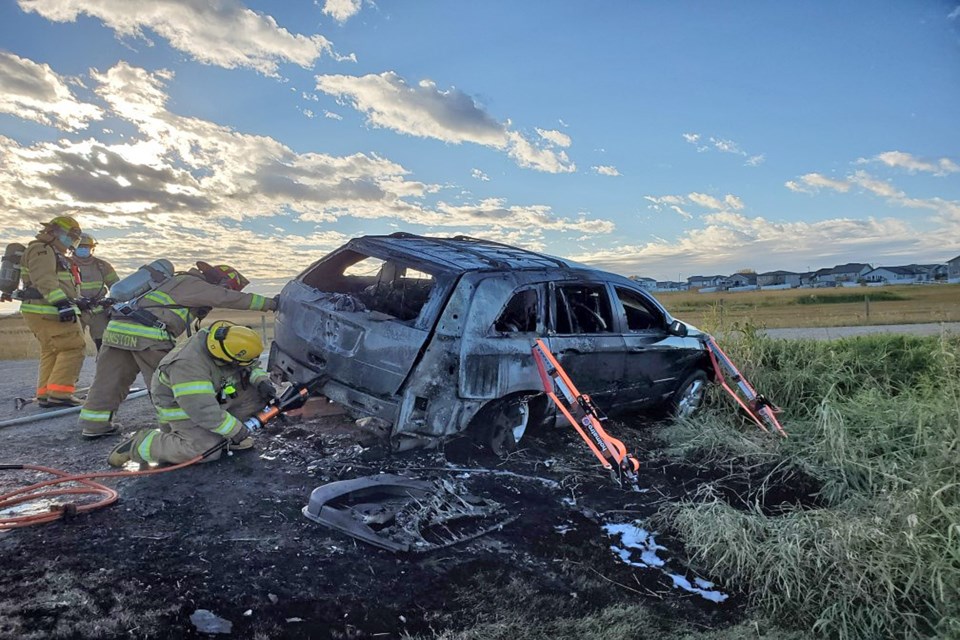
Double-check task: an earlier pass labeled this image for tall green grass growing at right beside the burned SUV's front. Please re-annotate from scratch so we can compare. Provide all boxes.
[659,332,960,639]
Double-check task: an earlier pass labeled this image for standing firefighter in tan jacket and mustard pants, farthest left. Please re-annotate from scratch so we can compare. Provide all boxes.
[20,216,85,407]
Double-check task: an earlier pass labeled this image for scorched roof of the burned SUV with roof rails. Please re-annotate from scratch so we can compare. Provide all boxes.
[347,232,600,273]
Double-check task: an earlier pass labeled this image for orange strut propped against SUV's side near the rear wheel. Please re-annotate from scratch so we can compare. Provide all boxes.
[533,338,640,487]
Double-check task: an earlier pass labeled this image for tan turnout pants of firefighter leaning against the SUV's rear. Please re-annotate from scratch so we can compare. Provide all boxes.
[78,344,169,433]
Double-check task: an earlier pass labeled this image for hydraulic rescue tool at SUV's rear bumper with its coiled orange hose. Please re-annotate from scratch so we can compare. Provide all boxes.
[0,376,323,531]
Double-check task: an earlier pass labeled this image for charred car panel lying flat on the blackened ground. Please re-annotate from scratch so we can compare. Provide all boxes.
[303,473,517,553]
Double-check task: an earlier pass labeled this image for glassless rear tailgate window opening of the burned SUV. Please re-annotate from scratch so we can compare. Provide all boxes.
[303,251,435,322]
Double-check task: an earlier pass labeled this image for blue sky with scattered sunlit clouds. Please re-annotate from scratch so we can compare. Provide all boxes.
[0,0,960,311]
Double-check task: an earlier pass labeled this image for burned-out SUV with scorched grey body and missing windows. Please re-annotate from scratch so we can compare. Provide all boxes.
[269,233,709,453]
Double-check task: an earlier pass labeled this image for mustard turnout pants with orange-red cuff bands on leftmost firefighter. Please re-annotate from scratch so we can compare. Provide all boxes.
[23,313,86,400]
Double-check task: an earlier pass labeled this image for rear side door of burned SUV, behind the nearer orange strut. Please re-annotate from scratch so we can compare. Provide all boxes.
[547,281,624,411]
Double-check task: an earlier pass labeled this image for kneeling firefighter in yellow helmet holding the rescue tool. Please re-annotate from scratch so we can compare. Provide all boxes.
[107,320,277,467]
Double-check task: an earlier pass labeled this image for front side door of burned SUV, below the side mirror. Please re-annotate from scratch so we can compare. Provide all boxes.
[612,285,692,406]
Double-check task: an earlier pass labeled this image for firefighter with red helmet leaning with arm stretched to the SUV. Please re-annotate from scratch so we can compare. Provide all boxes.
[79,262,277,438]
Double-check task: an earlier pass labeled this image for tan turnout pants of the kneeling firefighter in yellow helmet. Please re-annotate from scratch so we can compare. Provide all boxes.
[130,385,265,464]
